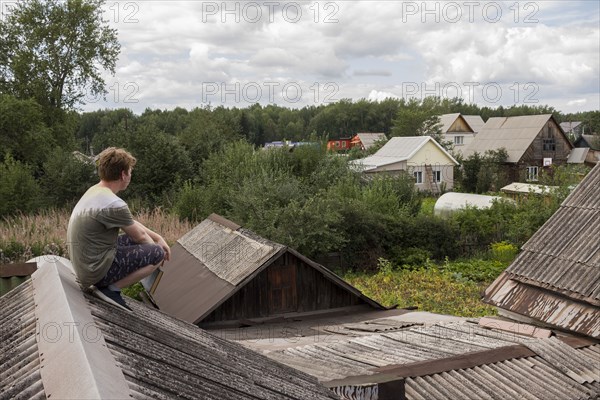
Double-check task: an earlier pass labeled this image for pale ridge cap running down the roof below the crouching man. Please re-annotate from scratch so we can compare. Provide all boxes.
[31,257,129,398]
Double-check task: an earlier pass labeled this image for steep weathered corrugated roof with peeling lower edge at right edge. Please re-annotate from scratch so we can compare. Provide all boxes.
[484,165,600,337]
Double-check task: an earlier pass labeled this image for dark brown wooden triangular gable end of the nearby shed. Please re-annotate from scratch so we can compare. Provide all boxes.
[198,251,365,326]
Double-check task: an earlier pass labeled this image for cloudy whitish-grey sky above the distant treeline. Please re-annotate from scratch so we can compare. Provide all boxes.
[89,0,600,113]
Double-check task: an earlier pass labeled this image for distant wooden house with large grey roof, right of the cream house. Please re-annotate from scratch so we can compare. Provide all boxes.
[463,114,573,182]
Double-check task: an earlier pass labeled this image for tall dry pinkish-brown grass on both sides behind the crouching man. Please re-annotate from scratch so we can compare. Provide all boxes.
[0,208,193,263]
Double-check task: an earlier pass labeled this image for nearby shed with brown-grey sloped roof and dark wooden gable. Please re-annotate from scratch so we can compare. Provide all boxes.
[145,214,383,326]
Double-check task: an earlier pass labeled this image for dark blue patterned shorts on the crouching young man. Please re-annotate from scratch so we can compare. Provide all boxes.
[94,235,165,288]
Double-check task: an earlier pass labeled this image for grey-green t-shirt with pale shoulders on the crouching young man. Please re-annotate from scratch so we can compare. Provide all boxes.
[67,185,134,287]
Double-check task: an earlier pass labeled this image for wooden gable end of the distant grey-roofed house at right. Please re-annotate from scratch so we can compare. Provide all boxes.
[519,118,572,167]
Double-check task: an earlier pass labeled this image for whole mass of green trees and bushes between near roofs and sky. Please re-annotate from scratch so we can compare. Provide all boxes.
[0,95,591,266]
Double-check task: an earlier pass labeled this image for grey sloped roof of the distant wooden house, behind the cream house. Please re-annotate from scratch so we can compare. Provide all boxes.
[464,114,552,163]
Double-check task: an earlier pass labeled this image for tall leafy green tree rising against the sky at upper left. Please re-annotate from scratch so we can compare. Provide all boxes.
[0,0,120,109]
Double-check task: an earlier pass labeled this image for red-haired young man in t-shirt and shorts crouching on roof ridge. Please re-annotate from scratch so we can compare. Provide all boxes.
[67,147,171,310]
